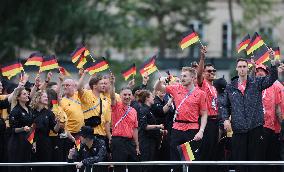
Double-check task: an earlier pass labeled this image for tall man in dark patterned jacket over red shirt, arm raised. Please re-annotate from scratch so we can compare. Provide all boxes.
[219,50,277,172]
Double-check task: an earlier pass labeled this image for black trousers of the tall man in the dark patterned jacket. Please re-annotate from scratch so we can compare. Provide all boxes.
[232,126,264,172]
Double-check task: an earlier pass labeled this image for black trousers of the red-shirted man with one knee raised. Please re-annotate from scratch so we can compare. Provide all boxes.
[170,129,200,172]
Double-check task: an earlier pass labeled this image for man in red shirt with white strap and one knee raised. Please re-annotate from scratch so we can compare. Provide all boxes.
[155,67,207,171]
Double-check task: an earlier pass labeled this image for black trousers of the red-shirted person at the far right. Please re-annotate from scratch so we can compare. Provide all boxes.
[263,128,281,172]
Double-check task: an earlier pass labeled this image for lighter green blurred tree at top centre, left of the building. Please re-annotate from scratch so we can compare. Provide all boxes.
[115,0,209,57]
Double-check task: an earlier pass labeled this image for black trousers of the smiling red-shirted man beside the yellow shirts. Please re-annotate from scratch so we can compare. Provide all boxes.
[111,136,139,172]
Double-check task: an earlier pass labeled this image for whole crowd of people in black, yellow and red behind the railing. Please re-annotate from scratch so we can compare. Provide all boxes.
[0,47,284,172]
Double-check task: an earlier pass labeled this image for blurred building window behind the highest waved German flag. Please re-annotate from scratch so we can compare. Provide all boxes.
[188,21,203,58]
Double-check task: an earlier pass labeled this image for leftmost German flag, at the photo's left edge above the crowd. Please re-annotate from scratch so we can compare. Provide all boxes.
[1,62,24,79]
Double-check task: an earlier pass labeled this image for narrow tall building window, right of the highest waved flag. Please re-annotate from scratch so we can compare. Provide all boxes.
[222,23,232,57]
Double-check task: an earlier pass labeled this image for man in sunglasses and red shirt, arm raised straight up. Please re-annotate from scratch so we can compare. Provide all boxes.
[197,47,219,172]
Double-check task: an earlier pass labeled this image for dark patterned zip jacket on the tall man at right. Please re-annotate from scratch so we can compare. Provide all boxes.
[219,66,278,133]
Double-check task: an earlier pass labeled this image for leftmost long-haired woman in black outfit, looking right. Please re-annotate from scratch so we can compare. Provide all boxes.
[8,87,33,172]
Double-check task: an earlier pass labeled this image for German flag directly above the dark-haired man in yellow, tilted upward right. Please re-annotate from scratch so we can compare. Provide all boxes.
[86,57,109,75]
